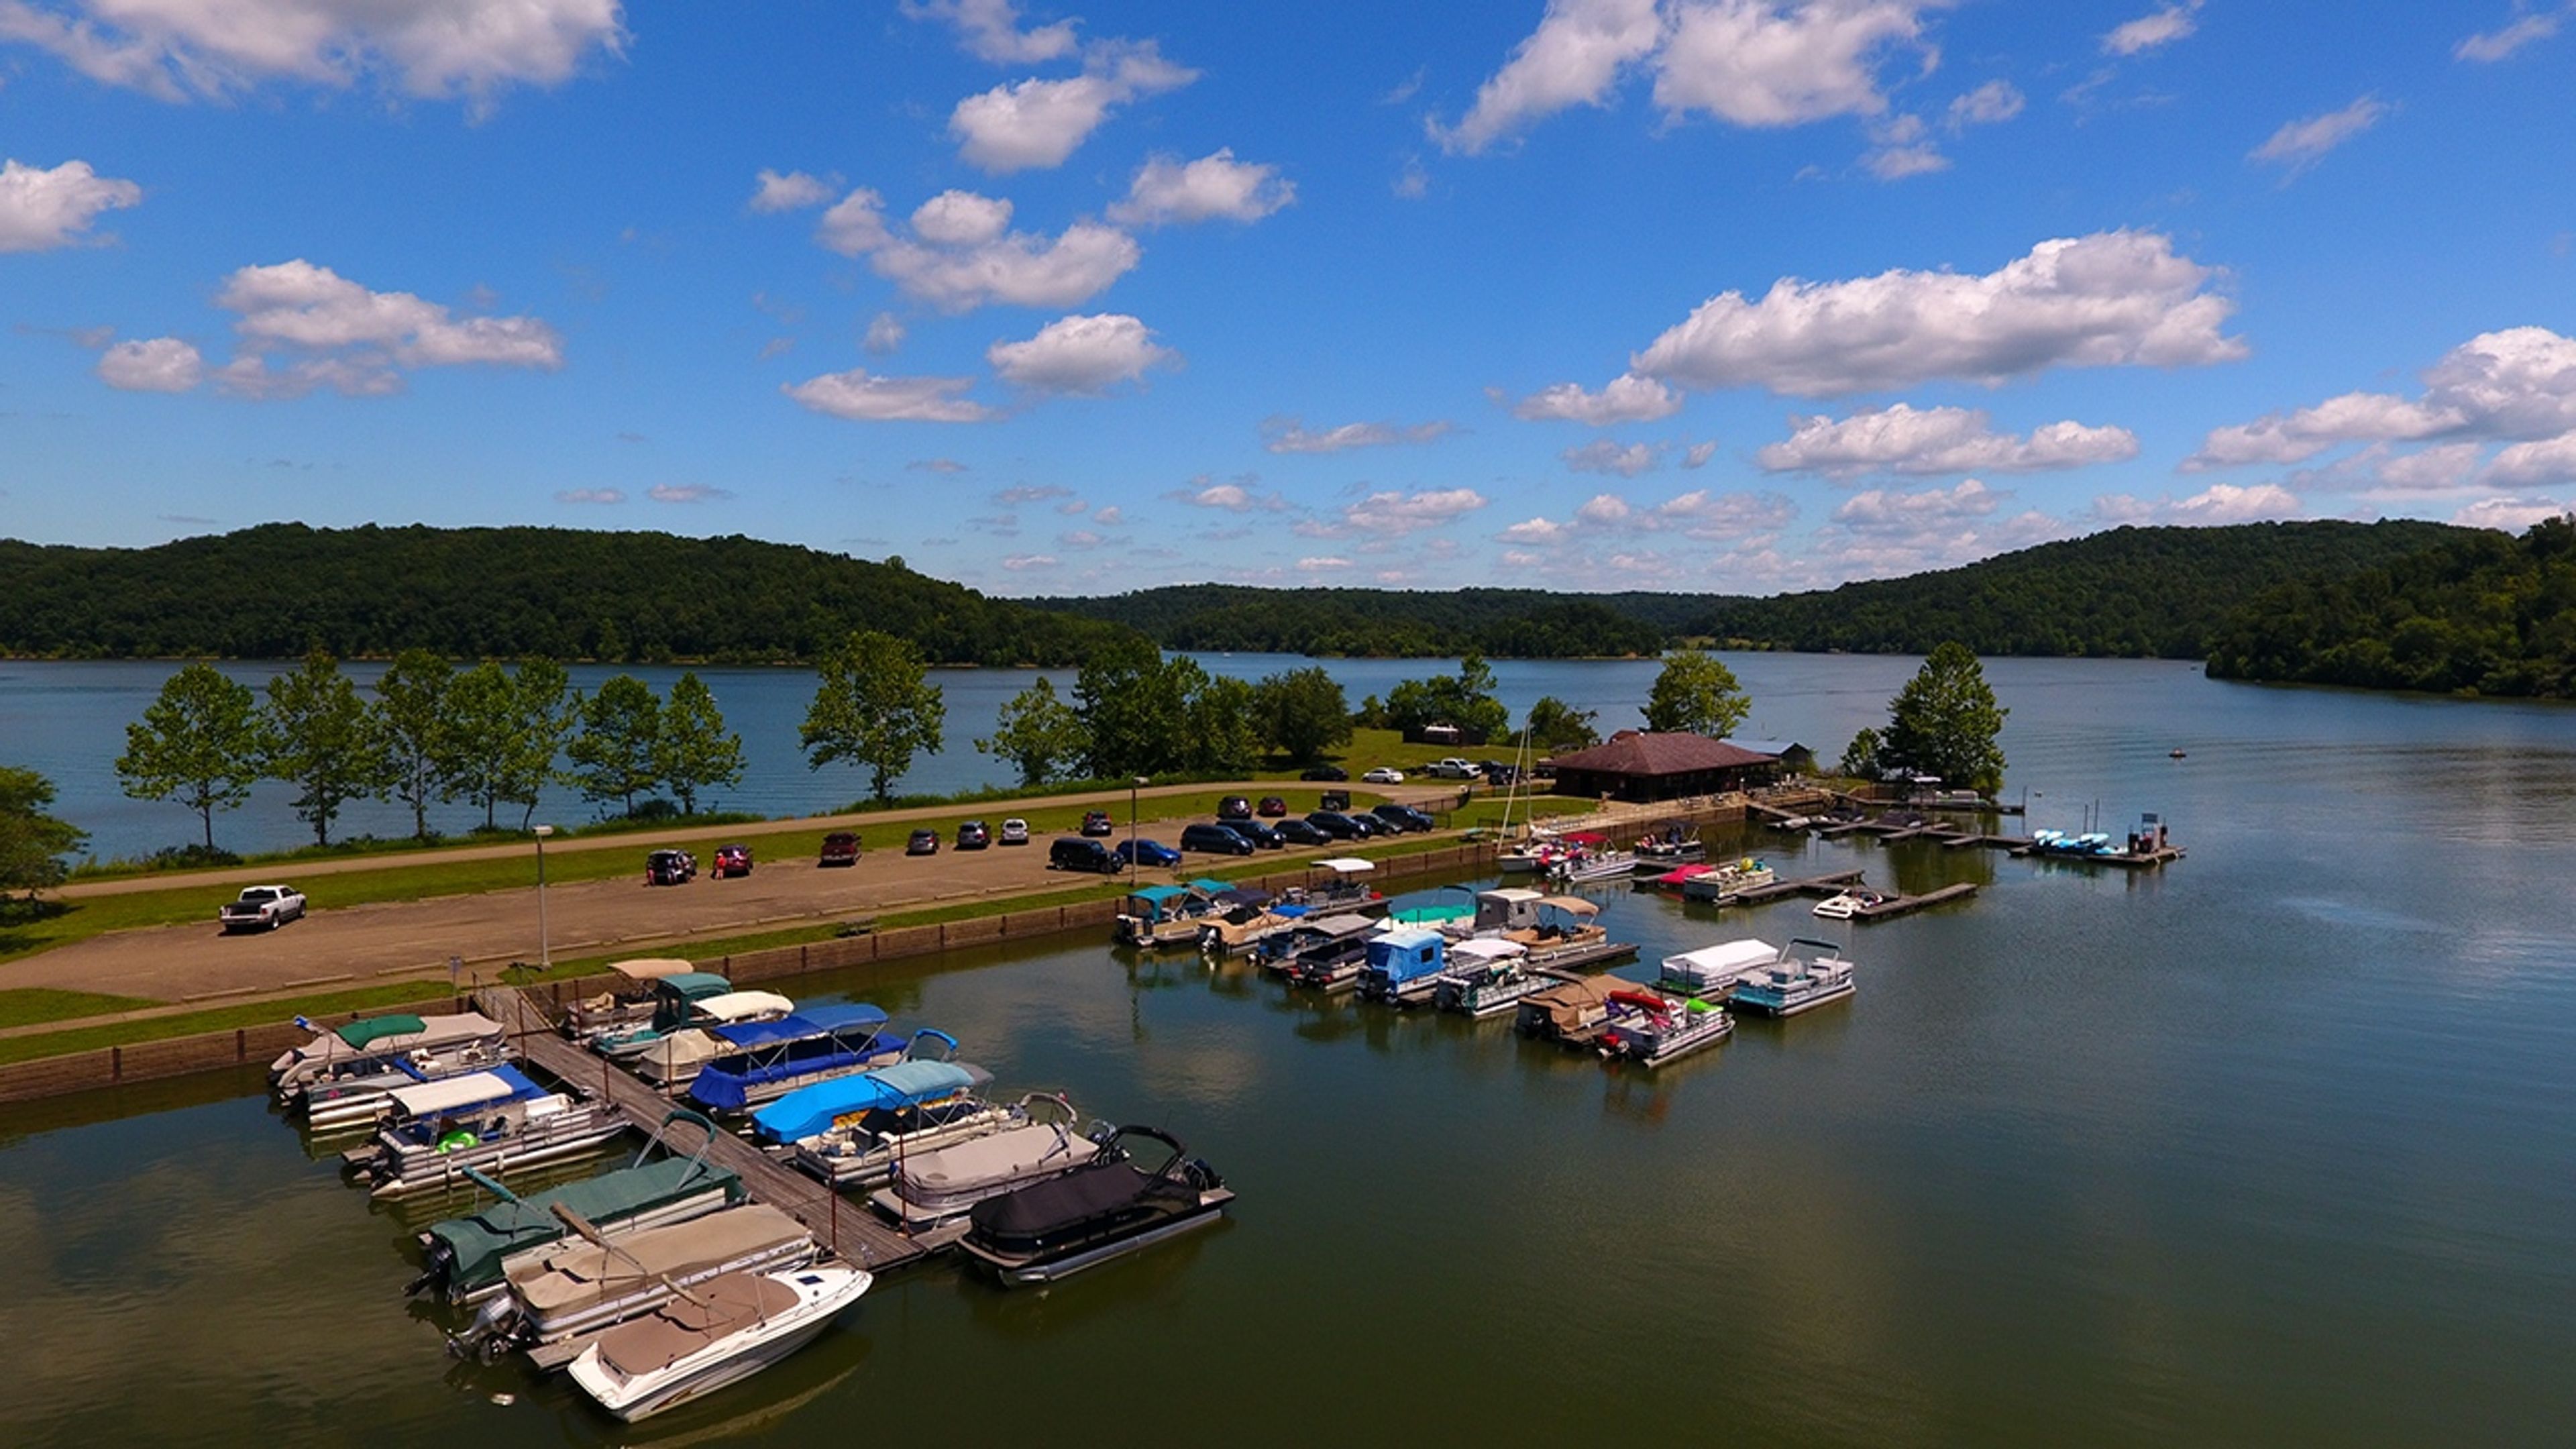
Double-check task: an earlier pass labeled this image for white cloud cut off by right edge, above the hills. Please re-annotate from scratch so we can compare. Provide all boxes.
[2182,327,2576,472]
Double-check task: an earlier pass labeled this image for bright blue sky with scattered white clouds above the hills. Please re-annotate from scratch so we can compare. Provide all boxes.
[0,0,2576,593]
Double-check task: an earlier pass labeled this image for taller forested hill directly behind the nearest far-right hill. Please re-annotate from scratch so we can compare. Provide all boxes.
[1698,519,2473,660]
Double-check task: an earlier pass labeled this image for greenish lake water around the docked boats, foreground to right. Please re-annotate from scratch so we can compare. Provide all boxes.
[0,660,2576,1446]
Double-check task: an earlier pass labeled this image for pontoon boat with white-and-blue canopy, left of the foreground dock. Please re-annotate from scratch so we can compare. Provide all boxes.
[340,1067,626,1199]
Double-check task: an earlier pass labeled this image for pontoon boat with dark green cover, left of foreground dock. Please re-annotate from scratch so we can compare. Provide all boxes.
[407,1112,745,1302]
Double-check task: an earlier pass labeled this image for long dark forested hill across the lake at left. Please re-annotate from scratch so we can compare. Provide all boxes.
[0,523,1126,665]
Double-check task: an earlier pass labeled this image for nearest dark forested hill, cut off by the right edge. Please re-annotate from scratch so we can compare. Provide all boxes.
[2210,519,2576,699]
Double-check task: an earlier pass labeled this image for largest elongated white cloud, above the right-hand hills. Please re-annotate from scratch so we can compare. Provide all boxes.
[1628,232,2246,397]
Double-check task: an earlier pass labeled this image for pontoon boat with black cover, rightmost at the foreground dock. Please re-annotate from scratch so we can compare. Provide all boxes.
[958,1127,1234,1284]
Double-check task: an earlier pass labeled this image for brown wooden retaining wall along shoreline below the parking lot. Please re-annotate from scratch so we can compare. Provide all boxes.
[0,843,1494,1101]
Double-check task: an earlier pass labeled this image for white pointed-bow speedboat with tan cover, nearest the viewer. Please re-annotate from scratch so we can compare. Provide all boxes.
[567,1260,873,1424]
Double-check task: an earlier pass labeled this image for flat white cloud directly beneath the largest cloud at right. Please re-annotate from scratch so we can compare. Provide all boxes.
[1754,402,2138,477]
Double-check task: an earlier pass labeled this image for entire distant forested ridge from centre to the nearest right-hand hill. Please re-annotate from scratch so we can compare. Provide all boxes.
[1036,521,2468,657]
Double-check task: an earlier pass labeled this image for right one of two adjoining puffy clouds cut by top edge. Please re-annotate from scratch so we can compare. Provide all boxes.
[1654,0,1929,126]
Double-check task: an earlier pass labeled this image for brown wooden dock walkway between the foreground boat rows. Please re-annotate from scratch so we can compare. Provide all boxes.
[474,985,956,1274]
